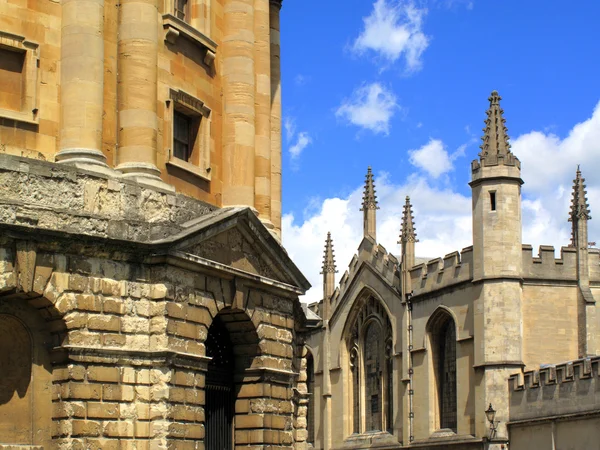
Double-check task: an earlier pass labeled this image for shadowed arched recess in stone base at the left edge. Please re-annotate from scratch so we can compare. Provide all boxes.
[0,299,52,446]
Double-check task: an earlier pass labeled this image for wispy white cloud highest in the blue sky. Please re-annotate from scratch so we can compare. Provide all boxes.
[352,0,429,71]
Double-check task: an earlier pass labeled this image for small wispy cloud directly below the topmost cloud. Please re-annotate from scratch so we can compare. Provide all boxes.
[335,83,400,135]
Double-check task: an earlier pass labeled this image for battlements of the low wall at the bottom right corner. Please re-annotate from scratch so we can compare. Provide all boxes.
[508,356,600,421]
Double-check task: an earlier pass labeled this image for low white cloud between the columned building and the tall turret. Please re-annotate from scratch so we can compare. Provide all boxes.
[282,174,471,302]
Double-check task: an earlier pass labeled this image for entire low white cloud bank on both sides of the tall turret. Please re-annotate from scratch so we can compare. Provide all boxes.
[283,103,600,302]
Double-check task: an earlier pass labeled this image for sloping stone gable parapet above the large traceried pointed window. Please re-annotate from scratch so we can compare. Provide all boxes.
[331,237,399,305]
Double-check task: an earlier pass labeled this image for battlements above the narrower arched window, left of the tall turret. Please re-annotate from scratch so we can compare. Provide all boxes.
[409,246,473,296]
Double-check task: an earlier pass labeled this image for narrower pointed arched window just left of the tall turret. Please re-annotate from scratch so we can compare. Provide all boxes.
[430,310,457,433]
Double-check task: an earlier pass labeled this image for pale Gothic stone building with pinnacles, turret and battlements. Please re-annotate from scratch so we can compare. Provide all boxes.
[306,91,600,450]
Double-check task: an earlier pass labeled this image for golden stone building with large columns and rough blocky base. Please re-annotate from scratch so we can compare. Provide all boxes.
[0,0,314,450]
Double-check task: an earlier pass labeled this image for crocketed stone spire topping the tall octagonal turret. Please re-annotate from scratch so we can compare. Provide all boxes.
[479,91,521,168]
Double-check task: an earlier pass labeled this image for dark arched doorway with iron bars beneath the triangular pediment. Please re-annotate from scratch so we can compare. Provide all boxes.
[205,316,235,450]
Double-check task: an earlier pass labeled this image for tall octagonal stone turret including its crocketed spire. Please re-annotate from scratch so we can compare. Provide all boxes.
[470,91,523,437]
